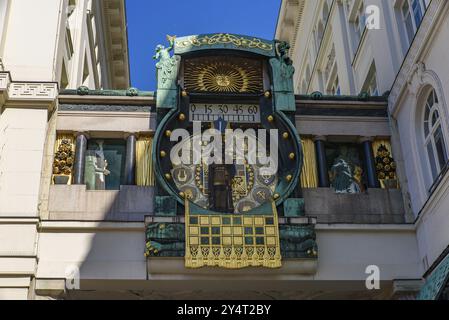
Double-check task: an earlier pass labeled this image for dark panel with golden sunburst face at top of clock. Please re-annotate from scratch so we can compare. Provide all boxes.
[184,57,263,93]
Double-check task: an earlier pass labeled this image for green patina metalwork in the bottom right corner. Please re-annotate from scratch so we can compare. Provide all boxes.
[417,254,449,300]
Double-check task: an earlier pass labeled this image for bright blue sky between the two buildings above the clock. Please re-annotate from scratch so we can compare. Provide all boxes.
[126,0,281,91]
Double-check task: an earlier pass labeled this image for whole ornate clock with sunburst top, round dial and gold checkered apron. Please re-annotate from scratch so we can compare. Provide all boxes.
[150,34,316,268]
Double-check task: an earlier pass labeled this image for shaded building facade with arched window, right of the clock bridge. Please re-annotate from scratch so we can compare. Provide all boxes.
[276,0,449,300]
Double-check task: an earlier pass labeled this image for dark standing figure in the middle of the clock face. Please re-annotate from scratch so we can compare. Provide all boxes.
[209,164,235,213]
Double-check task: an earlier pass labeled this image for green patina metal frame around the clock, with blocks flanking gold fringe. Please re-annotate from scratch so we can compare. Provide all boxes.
[146,34,317,259]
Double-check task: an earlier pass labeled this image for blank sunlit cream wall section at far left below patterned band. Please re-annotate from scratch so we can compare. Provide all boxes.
[0,107,47,217]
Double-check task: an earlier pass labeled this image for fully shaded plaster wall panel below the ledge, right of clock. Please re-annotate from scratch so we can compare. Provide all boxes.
[315,226,421,280]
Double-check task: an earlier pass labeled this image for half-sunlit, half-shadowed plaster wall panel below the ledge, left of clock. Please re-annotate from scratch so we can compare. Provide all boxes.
[37,223,146,281]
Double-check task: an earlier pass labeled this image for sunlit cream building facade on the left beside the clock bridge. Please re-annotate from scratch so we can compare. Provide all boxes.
[0,0,129,298]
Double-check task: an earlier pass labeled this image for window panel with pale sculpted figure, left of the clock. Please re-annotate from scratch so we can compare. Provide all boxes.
[84,139,126,190]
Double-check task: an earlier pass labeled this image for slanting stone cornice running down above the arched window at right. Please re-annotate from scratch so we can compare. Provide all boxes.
[389,0,447,116]
